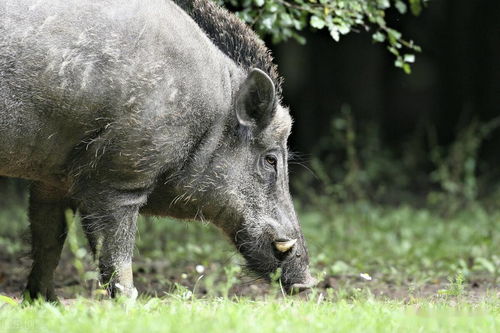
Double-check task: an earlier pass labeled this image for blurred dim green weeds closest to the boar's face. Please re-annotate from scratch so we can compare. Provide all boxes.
[292,105,420,203]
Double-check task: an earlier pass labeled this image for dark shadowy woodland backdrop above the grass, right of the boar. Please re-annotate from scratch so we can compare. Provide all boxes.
[272,1,500,205]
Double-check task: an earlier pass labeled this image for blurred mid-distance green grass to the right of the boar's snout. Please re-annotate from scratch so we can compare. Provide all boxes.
[302,204,500,282]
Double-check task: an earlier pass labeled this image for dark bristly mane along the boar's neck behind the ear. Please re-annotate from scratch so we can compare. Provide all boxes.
[174,0,281,96]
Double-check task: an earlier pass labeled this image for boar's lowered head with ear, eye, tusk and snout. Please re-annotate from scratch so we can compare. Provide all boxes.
[214,69,315,291]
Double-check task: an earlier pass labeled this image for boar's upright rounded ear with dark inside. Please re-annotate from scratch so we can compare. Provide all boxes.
[235,68,276,131]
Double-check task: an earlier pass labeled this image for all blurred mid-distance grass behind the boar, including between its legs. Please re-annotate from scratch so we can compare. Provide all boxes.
[0,197,500,296]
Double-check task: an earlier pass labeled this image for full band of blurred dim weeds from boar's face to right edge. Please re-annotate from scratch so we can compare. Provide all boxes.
[291,105,500,209]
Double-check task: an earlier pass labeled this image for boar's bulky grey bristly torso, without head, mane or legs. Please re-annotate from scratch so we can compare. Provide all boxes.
[0,1,238,186]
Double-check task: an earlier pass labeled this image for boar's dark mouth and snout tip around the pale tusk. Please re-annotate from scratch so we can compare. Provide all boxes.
[233,226,316,294]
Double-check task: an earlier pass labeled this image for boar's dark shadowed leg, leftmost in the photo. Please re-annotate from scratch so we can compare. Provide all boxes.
[24,183,70,302]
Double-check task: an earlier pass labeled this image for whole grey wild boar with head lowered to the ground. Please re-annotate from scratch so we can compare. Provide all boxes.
[0,0,312,300]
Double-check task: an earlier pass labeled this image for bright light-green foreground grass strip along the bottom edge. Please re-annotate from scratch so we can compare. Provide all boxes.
[0,296,500,333]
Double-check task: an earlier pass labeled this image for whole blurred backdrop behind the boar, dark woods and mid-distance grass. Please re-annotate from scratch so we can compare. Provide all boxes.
[0,0,500,299]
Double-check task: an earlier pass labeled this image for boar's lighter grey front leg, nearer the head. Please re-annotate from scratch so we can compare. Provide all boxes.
[79,186,147,299]
